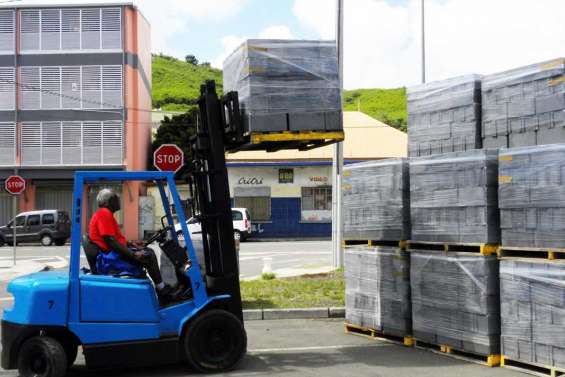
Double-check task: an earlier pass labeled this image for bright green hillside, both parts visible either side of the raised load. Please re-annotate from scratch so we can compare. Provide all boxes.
[153,55,407,131]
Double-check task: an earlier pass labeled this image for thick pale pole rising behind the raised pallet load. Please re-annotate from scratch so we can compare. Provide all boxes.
[332,0,344,268]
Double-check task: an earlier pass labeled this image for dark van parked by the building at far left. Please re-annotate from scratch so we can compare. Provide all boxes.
[0,209,71,246]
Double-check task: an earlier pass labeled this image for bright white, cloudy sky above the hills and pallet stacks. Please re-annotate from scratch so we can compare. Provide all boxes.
[8,0,565,89]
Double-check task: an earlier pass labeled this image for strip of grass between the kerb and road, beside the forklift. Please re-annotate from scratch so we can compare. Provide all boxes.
[241,270,345,309]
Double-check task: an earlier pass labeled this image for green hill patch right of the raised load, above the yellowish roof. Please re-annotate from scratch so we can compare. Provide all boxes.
[344,88,408,132]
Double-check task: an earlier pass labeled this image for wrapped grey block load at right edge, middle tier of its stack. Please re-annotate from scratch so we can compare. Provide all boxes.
[499,144,565,248]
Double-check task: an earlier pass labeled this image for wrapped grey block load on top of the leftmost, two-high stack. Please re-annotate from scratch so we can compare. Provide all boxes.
[342,159,410,241]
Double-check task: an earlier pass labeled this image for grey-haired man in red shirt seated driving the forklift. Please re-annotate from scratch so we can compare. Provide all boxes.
[88,189,173,297]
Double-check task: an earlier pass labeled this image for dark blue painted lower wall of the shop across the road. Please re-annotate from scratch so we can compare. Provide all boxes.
[245,198,332,238]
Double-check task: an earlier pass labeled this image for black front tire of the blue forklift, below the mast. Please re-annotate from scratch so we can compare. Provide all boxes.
[182,310,247,373]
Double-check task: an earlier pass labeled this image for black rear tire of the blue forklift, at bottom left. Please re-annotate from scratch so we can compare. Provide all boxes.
[18,336,67,377]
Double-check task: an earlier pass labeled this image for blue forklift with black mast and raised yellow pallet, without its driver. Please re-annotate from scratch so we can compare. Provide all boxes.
[1,81,343,377]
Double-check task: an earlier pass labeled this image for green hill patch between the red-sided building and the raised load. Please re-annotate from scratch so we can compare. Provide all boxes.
[152,55,222,111]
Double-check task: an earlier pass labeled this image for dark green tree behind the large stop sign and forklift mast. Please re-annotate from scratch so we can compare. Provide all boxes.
[148,107,198,179]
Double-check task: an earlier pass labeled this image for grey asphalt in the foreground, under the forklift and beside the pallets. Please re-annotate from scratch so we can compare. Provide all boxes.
[0,320,524,377]
